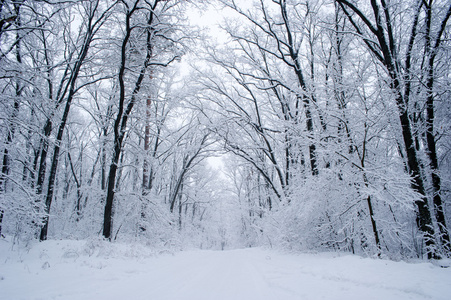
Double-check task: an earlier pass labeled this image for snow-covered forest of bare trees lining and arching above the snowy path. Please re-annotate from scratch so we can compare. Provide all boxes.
[0,0,451,260]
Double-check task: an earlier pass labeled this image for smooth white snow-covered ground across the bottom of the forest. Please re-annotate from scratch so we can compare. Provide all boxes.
[0,240,451,300]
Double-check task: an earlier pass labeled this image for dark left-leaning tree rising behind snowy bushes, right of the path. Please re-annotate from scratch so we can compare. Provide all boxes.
[221,0,325,175]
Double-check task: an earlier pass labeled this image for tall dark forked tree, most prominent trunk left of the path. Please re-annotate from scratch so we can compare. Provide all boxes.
[103,0,179,240]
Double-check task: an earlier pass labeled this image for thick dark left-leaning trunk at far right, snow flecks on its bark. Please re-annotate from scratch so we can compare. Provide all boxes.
[336,0,437,258]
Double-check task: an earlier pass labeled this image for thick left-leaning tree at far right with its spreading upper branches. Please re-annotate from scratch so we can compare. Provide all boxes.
[337,0,449,258]
